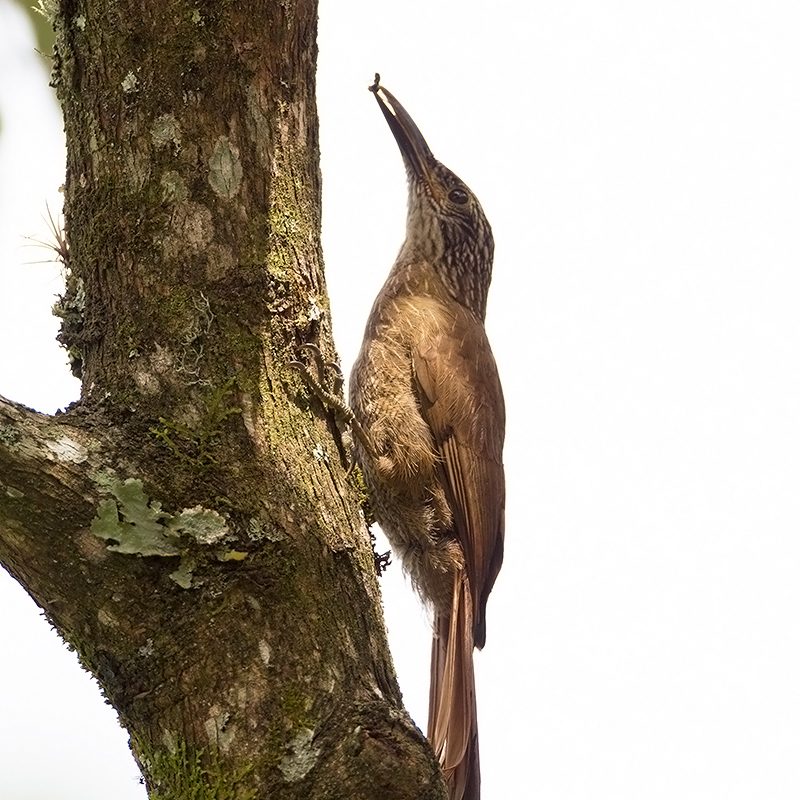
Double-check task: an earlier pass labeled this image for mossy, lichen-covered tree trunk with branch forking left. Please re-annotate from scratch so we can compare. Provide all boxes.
[0,0,445,800]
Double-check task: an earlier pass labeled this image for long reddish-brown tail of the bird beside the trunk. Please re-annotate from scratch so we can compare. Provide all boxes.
[428,571,481,800]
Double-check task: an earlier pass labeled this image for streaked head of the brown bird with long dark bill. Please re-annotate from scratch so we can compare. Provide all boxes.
[370,75,494,320]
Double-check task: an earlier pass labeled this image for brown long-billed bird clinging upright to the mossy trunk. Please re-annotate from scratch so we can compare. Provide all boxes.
[350,75,505,800]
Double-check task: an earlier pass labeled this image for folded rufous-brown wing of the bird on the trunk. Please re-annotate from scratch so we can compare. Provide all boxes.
[413,309,505,647]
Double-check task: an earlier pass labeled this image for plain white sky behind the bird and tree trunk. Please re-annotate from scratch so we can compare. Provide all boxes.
[0,0,800,800]
